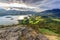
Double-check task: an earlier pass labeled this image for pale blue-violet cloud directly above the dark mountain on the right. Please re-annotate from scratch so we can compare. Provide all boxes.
[37,0,60,10]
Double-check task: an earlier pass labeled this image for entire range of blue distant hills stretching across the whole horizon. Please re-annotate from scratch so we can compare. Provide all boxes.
[0,9,60,18]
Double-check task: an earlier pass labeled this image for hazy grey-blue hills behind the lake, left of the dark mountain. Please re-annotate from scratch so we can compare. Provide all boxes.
[0,9,37,16]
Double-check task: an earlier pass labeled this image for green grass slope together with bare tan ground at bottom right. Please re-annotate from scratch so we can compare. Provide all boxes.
[38,28,60,40]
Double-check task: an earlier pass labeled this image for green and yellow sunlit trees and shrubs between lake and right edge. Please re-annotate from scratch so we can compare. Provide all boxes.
[18,16,60,33]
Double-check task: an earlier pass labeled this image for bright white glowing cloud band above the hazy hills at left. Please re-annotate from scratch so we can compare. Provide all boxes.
[0,3,35,9]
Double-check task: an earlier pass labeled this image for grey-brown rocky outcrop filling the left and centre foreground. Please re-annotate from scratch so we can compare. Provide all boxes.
[0,27,48,40]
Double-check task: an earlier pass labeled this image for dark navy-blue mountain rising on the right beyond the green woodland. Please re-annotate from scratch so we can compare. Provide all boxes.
[38,9,60,18]
